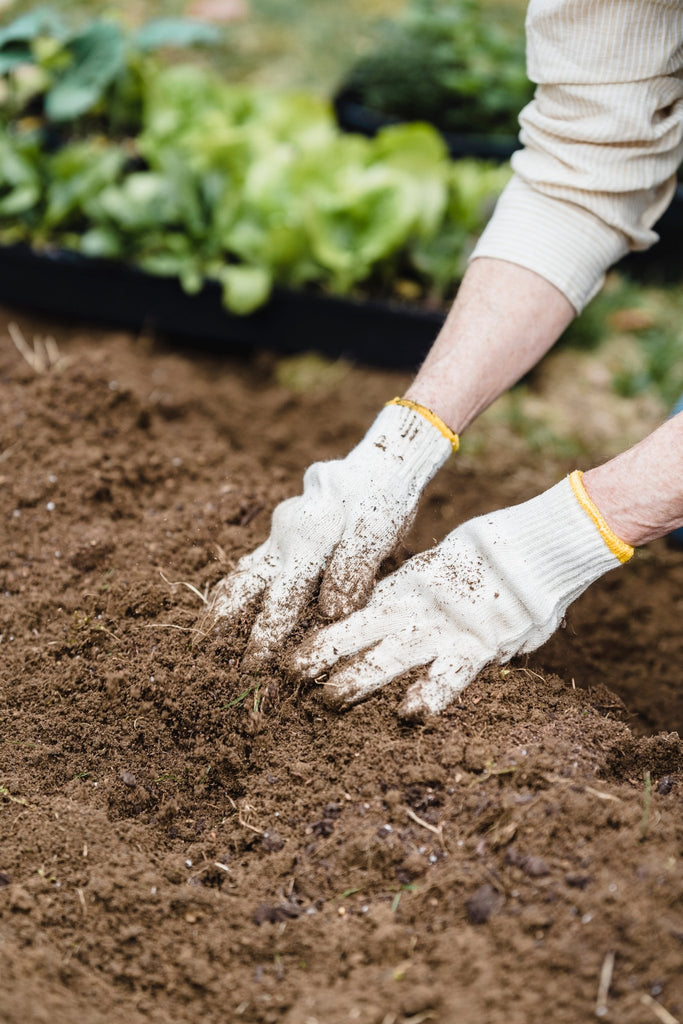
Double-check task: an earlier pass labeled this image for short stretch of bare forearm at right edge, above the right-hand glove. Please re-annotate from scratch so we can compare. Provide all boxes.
[584,413,683,547]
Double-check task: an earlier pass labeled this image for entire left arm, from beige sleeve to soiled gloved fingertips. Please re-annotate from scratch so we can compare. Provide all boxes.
[205,0,683,658]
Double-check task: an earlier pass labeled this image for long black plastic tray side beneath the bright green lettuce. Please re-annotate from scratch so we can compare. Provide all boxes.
[0,246,443,369]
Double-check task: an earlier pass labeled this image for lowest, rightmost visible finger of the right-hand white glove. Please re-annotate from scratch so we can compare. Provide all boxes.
[398,643,490,722]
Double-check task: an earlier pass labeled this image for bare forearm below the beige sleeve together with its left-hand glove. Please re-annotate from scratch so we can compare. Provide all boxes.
[201,259,573,666]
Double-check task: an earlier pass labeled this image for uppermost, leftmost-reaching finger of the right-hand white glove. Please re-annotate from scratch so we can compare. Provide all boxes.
[290,585,410,679]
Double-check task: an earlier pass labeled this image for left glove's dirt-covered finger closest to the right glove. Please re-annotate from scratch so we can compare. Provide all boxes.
[317,523,404,618]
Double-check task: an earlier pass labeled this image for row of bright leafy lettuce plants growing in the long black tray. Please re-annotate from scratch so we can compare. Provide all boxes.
[0,20,509,313]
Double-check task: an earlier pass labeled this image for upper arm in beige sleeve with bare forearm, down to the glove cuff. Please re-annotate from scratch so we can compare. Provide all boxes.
[407,0,683,432]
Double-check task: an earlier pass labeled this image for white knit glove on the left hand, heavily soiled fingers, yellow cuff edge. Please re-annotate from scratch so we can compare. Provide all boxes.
[202,399,458,668]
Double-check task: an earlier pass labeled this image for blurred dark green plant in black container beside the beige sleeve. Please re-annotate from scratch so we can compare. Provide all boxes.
[342,0,532,134]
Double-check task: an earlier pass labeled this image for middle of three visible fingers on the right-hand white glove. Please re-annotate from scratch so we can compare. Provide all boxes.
[323,636,433,708]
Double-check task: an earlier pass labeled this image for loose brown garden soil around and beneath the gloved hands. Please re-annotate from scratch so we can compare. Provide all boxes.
[0,309,683,1024]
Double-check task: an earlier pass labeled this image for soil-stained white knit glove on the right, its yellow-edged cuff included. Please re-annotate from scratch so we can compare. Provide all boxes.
[292,471,633,719]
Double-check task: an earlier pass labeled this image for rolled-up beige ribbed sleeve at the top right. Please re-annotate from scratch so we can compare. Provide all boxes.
[472,0,683,310]
